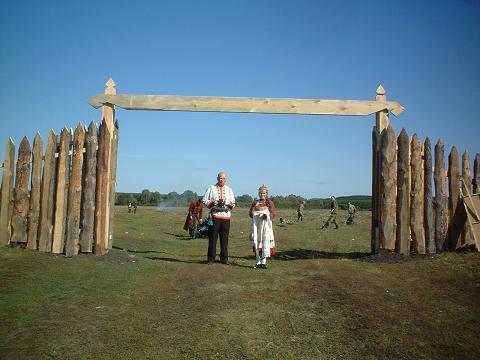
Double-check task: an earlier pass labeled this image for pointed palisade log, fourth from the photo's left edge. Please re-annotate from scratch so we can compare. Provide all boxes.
[38,129,57,252]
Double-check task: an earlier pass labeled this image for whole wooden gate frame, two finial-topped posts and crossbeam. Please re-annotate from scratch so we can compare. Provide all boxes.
[89,79,404,253]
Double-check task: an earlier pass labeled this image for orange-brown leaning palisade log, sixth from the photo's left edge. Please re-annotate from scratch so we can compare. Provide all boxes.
[65,124,85,257]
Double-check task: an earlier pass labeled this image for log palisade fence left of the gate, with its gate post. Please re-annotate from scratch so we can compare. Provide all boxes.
[0,83,118,257]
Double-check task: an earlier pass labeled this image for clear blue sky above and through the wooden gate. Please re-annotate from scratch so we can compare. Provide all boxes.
[0,0,480,198]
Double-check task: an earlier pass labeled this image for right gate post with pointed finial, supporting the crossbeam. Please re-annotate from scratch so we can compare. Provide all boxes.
[371,85,390,253]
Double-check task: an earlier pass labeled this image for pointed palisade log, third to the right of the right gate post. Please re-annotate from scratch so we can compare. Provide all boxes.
[410,134,425,254]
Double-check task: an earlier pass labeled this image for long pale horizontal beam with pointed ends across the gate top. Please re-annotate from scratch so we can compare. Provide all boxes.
[89,94,404,115]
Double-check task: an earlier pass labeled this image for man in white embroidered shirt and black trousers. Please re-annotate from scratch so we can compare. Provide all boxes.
[203,171,235,265]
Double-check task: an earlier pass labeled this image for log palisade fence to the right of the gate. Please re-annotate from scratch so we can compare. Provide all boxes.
[372,124,480,255]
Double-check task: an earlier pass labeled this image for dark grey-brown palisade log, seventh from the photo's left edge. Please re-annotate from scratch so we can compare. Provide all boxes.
[80,121,98,252]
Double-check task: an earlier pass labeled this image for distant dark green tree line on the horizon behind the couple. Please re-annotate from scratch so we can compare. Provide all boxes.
[115,189,372,210]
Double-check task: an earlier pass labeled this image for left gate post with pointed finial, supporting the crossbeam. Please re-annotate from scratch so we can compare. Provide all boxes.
[95,79,117,255]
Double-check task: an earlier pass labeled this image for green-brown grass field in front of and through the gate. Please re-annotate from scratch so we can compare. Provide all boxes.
[0,207,480,360]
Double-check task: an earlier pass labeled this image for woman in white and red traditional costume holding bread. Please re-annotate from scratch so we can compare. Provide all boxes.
[249,185,275,269]
